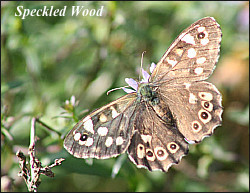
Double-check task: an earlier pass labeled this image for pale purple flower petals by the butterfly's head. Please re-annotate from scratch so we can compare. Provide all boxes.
[122,63,156,93]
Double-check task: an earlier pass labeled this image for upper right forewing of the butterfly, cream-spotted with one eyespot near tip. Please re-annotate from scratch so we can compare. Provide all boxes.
[151,17,222,84]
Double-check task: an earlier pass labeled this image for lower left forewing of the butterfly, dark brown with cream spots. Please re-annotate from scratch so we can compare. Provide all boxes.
[64,93,136,159]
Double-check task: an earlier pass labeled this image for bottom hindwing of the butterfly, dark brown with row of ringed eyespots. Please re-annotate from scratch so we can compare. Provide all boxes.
[128,103,188,171]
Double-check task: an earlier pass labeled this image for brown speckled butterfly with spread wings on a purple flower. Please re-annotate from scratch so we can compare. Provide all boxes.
[64,17,222,171]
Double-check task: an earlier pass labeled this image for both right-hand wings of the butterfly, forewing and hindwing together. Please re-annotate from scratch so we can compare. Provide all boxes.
[148,17,222,142]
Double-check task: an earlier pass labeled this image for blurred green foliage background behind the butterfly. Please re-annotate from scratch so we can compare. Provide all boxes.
[1,1,249,192]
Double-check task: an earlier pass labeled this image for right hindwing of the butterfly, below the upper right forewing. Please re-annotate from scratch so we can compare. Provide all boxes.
[159,81,222,142]
